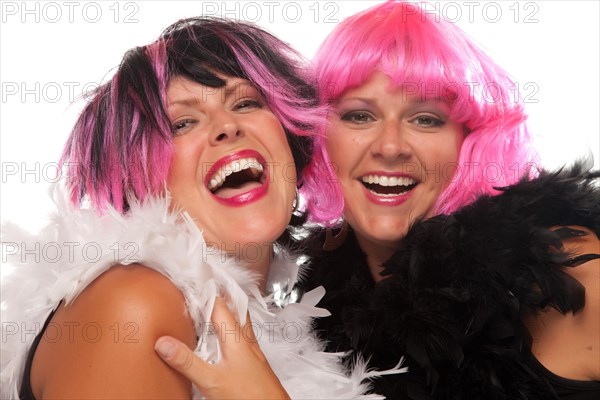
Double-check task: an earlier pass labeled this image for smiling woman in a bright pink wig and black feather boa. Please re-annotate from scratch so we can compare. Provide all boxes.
[302,1,600,399]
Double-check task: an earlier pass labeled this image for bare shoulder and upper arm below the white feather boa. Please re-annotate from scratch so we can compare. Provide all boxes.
[31,265,196,399]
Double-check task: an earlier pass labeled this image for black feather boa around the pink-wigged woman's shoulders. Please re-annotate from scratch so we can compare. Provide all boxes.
[304,166,600,400]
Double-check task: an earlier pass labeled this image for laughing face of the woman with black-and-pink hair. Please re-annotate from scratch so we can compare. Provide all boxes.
[167,77,296,262]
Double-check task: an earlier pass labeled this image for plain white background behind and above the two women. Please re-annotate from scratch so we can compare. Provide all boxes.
[0,0,600,230]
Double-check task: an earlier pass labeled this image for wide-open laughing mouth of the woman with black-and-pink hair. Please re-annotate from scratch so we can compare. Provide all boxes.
[206,150,269,206]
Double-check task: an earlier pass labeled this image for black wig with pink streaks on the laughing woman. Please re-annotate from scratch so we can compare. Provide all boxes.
[61,18,324,212]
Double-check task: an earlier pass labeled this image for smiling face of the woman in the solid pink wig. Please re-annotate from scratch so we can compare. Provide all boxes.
[327,72,464,261]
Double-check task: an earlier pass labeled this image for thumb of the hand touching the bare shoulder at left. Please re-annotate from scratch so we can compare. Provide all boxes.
[154,336,211,389]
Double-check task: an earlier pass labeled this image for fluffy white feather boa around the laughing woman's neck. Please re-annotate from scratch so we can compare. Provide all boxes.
[0,191,400,399]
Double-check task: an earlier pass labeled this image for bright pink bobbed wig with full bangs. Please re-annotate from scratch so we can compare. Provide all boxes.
[303,1,537,224]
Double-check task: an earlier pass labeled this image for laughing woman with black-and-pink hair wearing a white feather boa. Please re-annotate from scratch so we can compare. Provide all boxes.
[1,18,384,399]
